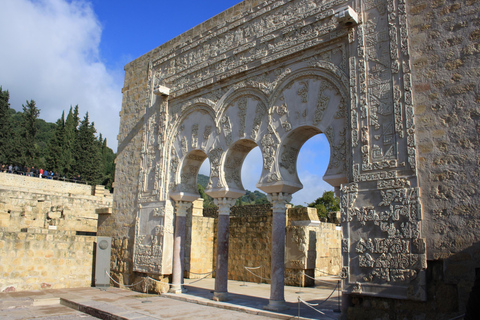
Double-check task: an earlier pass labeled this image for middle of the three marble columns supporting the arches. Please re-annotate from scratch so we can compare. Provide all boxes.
[213,198,236,301]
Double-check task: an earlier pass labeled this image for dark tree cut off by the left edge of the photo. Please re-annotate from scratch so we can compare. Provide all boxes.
[0,86,12,164]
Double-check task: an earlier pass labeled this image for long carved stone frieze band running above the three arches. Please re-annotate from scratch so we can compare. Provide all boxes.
[153,0,347,97]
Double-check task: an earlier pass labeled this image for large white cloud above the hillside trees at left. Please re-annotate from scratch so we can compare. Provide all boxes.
[0,0,123,150]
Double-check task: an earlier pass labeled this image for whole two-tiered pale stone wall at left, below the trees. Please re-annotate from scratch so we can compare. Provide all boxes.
[0,173,113,292]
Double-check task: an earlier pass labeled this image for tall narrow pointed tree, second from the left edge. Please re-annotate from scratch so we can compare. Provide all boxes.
[21,100,40,166]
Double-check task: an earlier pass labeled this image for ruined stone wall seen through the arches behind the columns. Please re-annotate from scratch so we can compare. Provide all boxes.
[185,205,342,286]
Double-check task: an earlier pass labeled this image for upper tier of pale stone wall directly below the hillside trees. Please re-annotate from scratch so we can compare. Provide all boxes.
[0,173,113,233]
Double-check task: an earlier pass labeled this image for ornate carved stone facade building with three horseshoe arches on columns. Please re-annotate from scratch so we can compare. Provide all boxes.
[99,0,478,314]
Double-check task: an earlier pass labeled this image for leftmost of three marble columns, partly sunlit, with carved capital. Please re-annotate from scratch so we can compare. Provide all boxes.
[168,201,192,293]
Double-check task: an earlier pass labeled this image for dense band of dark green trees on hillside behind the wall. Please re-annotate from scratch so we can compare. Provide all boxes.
[0,86,116,189]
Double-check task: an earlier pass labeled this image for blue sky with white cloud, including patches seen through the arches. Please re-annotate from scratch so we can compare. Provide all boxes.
[0,0,331,205]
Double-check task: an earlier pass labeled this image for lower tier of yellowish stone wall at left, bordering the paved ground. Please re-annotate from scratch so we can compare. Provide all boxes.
[0,230,96,292]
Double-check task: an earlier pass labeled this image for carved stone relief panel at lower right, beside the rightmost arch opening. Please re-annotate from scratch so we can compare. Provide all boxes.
[341,178,426,300]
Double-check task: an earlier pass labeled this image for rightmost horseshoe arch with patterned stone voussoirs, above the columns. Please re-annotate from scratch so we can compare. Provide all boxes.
[259,67,348,191]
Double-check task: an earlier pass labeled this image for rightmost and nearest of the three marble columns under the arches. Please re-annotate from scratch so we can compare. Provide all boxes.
[265,193,292,311]
